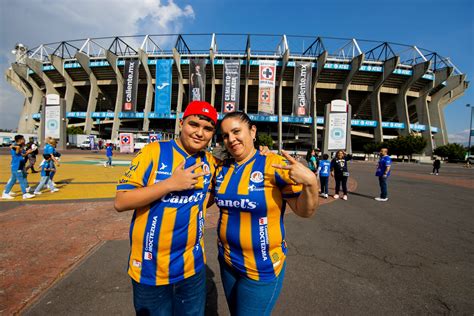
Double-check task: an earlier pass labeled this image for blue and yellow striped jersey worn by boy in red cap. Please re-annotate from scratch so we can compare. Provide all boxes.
[117,140,216,285]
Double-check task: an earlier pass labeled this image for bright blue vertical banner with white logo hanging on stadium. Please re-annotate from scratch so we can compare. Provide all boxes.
[155,59,173,114]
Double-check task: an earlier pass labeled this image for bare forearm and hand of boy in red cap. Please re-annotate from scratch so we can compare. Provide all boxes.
[114,161,206,212]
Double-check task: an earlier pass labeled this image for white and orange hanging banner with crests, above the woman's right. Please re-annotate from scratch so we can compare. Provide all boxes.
[258,60,276,115]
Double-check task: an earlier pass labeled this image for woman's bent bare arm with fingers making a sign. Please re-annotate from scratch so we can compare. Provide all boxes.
[273,151,319,217]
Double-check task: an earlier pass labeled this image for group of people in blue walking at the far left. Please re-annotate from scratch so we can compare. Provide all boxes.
[2,135,61,200]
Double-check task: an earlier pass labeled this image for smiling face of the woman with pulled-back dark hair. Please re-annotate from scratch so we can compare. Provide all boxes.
[221,118,257,161]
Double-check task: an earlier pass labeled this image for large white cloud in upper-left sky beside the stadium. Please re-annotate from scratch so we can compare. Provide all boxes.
[0,0,194,128]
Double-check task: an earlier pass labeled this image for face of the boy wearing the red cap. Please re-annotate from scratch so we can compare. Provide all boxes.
[179,115,215,155]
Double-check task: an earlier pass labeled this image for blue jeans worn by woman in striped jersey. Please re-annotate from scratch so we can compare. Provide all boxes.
[219,259,286,316]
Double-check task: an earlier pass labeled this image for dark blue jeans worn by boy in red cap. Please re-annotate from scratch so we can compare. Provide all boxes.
[132,267,206,316]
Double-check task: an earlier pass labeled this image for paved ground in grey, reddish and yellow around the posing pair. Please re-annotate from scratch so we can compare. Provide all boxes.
[0,153,474,315]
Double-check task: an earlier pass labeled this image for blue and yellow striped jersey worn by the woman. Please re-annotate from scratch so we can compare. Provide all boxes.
[214,152,302,281]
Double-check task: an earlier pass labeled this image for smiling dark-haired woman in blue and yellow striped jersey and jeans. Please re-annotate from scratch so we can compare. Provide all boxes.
[214,112,318,315]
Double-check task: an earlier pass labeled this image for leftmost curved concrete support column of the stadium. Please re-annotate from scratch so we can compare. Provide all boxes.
[12,63,44,136]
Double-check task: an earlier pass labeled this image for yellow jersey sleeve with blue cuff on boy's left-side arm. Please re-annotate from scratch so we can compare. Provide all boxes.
[117,145,153,191]
